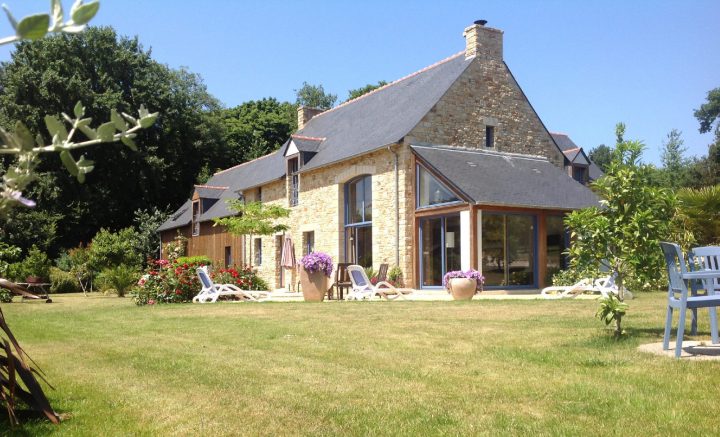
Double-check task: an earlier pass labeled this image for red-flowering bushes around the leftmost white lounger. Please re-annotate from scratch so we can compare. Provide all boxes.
[133,259,268,305]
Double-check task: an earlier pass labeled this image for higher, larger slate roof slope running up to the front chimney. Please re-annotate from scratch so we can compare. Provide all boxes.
[296,52,472,172]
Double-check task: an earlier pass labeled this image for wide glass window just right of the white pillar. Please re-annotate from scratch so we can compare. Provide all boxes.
[482,213,536,287]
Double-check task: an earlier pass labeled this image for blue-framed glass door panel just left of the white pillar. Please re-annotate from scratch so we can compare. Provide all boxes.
[420,214,460,287]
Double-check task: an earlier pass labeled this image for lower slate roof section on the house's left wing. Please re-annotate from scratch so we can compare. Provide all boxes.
[158,147,285,232]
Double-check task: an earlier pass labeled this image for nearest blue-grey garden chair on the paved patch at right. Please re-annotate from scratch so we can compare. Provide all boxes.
[660,242,720,358]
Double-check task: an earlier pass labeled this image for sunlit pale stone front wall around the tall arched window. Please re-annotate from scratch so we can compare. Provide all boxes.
[249,145,414,288]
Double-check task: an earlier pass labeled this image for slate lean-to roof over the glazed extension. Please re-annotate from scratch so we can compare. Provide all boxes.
[411,145,599,209]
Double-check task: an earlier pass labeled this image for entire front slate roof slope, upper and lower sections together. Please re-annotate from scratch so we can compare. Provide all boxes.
[158,51,472,231]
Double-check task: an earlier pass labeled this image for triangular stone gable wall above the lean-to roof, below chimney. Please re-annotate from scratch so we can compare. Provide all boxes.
[405,58,564,167]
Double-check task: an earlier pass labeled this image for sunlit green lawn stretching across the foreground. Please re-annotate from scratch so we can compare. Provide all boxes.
[0,293,720,436]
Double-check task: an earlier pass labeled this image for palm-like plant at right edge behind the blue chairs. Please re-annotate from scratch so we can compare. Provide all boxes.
[677,185,720,246]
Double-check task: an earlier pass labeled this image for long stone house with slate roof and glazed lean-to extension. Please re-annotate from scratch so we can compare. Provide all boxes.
[158,21,597,289]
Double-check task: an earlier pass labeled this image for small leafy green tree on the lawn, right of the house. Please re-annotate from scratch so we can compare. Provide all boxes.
[565,125,675,335]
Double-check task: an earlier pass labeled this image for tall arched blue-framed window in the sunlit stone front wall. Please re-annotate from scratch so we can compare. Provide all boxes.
[345,176,372,267]
